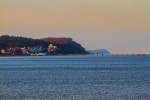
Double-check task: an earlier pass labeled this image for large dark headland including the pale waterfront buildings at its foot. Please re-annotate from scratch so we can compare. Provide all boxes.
[0,35,88,56]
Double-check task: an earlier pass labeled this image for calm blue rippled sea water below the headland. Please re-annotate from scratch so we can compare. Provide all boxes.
[0,56,150,100]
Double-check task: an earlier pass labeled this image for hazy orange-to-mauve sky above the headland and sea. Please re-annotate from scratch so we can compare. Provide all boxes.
[0,0,150,53]
